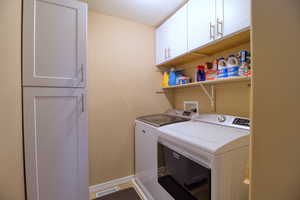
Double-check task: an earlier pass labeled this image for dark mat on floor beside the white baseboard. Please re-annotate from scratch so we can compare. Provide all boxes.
[97,188,141,200]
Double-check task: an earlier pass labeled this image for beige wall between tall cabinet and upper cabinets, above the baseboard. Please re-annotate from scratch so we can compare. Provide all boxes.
[88,11,170,185]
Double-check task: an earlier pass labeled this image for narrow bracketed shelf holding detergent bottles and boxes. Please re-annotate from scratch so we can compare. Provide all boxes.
[163,76,251,89]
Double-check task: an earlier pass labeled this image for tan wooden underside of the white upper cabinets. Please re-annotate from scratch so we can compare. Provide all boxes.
[157,28,250,67]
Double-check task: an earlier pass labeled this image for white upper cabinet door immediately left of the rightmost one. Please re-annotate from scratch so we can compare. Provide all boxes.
[188,0,216,51]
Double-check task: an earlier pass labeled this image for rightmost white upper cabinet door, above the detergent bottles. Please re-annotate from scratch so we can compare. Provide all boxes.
[216,0,251,38]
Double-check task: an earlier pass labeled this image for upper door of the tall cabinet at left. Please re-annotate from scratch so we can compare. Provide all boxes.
[23,0,87,87]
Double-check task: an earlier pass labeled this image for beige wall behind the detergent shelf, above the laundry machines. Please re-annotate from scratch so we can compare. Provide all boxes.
[174,43,250,117]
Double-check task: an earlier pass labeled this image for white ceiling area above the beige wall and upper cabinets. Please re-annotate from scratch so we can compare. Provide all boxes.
[88,0,187,26]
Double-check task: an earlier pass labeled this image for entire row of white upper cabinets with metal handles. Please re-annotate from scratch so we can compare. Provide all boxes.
[156,0,251,65]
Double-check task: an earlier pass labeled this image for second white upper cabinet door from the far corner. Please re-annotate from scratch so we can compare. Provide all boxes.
[167,4,187,60]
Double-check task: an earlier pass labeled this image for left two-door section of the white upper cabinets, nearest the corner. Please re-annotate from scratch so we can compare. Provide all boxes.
[156,5,187,64]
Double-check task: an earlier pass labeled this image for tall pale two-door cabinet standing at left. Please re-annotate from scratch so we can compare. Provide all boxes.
[22,0,89,200]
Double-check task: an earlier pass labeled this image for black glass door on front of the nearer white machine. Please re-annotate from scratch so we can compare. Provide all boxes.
[157,143,211,200]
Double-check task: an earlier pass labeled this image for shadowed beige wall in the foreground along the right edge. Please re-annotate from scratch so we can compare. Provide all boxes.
[251,0,300,200]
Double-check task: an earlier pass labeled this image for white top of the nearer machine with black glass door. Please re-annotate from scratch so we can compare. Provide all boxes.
[158,121,250,155]
